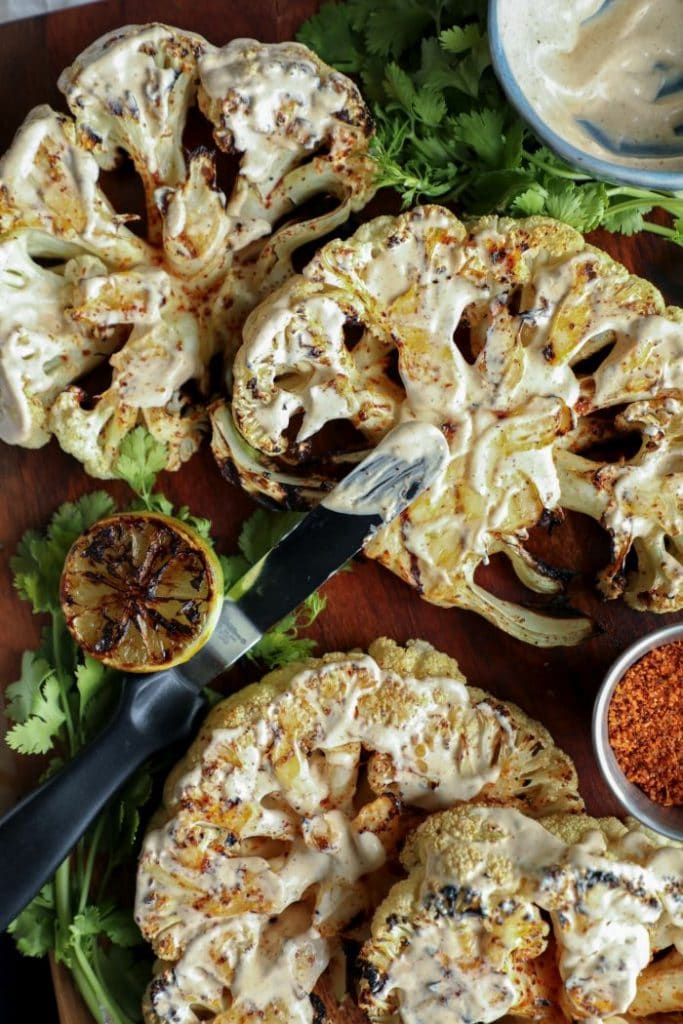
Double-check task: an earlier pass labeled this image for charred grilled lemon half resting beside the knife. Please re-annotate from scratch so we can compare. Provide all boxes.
[60,512,223,672]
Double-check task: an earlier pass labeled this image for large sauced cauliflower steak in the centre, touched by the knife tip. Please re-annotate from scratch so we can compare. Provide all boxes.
[227,207,683,646]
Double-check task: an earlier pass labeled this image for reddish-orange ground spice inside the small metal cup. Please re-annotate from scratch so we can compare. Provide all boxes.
[608,641,683,807]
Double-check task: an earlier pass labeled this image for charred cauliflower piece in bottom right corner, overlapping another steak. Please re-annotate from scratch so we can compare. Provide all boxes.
[359,806,683,1024]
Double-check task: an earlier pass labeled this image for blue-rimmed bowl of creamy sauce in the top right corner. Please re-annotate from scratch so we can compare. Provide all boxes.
[488,0,683,191]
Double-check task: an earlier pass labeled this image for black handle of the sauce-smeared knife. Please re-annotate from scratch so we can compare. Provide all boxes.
[0,670,204,931]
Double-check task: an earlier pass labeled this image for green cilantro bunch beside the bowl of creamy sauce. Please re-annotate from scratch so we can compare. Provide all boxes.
[298,0,683,245]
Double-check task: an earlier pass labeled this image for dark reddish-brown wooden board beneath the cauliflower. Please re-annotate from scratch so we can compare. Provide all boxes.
[0,0,683,1024]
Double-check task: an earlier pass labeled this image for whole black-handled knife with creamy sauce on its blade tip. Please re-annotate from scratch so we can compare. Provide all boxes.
[0,422,447,930]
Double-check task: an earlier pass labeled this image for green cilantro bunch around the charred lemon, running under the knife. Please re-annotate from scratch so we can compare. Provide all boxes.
[5,428,325,1024]
